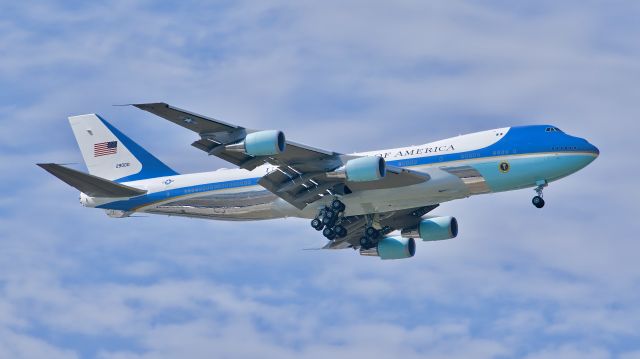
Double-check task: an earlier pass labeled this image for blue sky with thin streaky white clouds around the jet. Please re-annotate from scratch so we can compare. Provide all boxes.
[0,0,640,359]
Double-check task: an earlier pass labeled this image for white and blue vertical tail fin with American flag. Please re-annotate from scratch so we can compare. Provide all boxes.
[69,114,178,182]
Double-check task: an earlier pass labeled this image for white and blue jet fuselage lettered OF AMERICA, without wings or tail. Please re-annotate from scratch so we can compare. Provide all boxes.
[81,125,599,220]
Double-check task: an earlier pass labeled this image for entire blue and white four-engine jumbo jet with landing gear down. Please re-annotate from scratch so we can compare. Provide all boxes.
[38,103,599,259]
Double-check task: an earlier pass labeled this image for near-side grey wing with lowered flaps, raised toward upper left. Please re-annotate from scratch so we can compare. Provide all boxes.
[133,103,429,209]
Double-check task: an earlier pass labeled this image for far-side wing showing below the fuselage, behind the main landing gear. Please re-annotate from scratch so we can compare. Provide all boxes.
[322,204,439,249]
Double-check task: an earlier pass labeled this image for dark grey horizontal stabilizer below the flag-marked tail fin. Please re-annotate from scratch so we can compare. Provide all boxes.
[38,163,147,197]
